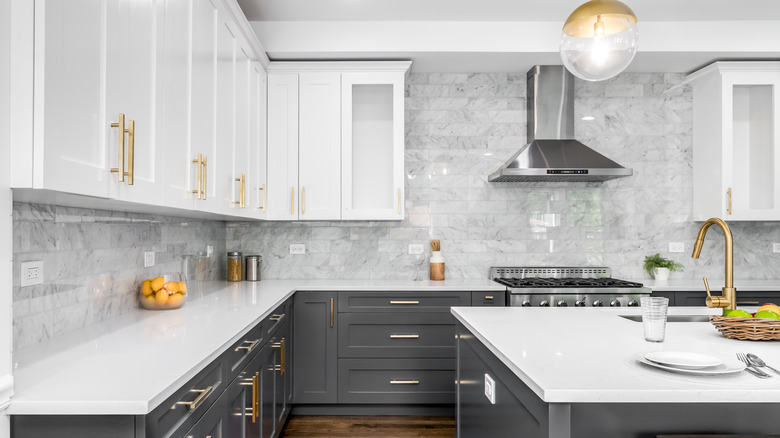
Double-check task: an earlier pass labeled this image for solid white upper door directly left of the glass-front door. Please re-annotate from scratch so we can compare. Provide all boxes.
[298,72,341,220]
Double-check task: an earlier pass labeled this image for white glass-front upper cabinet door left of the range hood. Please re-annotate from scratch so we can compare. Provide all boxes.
[341,71,404,220]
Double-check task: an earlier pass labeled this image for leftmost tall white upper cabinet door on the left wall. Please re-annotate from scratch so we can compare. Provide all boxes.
[31,0,109,197]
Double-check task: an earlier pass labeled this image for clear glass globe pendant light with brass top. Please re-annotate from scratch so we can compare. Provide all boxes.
[560,0,639,81]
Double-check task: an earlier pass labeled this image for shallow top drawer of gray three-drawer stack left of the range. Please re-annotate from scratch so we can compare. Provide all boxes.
[339,292,471,313]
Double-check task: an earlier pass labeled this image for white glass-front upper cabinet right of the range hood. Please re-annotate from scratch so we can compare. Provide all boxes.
[689,62,780,221]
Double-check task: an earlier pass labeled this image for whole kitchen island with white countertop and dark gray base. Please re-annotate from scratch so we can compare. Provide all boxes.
[452,307,780,438]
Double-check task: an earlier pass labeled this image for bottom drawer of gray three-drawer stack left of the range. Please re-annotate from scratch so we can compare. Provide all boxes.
[338,359,455,404]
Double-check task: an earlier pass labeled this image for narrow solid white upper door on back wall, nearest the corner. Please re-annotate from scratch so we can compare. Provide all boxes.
[266,73,299,221]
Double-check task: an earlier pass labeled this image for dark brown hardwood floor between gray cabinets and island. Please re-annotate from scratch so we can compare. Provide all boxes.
[282,415,455,438]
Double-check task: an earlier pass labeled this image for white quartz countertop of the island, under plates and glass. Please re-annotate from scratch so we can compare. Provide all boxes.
[452,306,780,403]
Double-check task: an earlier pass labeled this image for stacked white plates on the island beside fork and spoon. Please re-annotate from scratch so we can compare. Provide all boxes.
[639,351,745,375]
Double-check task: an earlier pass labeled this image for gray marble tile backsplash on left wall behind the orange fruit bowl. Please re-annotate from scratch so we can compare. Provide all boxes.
[13,203,225,349]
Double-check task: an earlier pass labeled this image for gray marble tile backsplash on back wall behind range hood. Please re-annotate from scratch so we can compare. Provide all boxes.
[227,73,780,279]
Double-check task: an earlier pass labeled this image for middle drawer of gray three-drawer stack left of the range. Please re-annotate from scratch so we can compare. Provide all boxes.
[338,313,455,358]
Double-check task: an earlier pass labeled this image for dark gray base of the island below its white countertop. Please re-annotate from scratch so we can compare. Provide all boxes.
[457,323,780,438]
